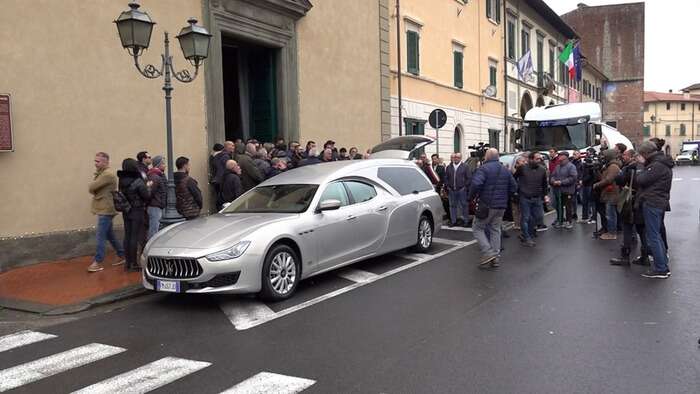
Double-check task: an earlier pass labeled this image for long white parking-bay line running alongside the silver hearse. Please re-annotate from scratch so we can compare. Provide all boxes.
[227,240,476,331]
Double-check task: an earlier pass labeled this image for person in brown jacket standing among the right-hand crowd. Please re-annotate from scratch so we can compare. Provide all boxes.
[593,149,622,240]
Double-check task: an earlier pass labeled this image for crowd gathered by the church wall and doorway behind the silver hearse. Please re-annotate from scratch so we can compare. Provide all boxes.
[88,138,369,272]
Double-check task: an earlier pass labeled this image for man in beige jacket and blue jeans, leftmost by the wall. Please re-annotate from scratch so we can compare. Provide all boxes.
[88,152,124,272]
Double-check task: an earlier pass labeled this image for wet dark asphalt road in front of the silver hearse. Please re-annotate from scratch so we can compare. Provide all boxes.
[0,168,700,393]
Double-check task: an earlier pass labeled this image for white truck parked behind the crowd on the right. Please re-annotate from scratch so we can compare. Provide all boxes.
[515,103,633,157]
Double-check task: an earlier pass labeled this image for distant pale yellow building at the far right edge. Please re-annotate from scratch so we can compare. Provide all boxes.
[644,90,700,157]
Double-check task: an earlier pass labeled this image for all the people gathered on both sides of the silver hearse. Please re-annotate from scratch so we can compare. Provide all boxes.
[88,138,673,278]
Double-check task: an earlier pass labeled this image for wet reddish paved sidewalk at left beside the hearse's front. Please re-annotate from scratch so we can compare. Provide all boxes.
[0,254,145,315]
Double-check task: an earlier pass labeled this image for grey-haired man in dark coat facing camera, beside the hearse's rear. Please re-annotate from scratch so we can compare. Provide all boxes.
[445,153,472,226]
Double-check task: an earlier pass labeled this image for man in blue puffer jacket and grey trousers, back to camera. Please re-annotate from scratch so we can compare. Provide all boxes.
[469,148,518,268]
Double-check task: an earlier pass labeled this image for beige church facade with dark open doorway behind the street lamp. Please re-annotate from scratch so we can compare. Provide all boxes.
[0,0,390,271]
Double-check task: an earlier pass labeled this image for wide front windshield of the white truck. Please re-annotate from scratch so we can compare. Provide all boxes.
[522,123,589,151]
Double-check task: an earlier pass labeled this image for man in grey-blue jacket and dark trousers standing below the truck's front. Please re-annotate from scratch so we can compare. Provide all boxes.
[549,151,578,230]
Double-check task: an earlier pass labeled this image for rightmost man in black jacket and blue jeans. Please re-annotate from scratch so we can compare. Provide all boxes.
[635,141,673,279]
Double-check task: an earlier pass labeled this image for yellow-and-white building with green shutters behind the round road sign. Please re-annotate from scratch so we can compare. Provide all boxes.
[388,0,504,156]
